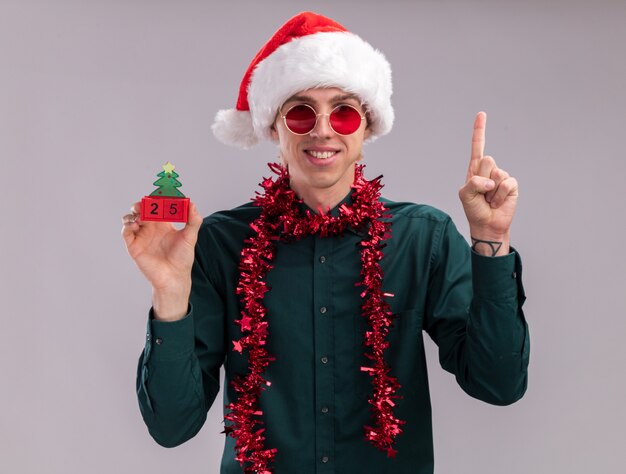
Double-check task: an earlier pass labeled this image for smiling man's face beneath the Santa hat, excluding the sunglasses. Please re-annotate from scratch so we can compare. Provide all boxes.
[272,88,370,204]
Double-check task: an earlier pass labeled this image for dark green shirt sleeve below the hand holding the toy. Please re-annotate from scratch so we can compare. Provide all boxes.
[136,239,225,447]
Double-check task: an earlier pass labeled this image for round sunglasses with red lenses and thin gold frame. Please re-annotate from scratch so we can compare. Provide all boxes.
[281,104,365,135]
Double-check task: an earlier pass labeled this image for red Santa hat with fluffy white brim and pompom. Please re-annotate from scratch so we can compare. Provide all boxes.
[212,12,394,148]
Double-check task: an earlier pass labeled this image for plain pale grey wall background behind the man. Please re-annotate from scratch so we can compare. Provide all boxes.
[0,0,626,474]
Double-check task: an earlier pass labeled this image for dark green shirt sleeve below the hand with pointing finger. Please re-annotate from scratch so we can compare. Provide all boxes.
[425,220,530,405]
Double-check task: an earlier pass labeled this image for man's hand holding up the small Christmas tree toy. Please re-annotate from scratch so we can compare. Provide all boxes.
[122,202,202,321]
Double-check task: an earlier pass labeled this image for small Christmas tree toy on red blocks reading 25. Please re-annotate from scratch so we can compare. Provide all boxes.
[141,161,189,222]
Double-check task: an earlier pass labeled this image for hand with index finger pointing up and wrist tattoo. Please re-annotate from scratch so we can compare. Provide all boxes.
[459,112,518,255]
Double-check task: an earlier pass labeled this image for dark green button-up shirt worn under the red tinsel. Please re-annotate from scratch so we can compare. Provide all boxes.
[137,200,529,474]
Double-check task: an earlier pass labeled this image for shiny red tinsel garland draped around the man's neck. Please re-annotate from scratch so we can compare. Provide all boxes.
[224,163,404,474]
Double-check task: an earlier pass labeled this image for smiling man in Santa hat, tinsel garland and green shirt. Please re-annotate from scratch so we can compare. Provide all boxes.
[122,13,529,474]
